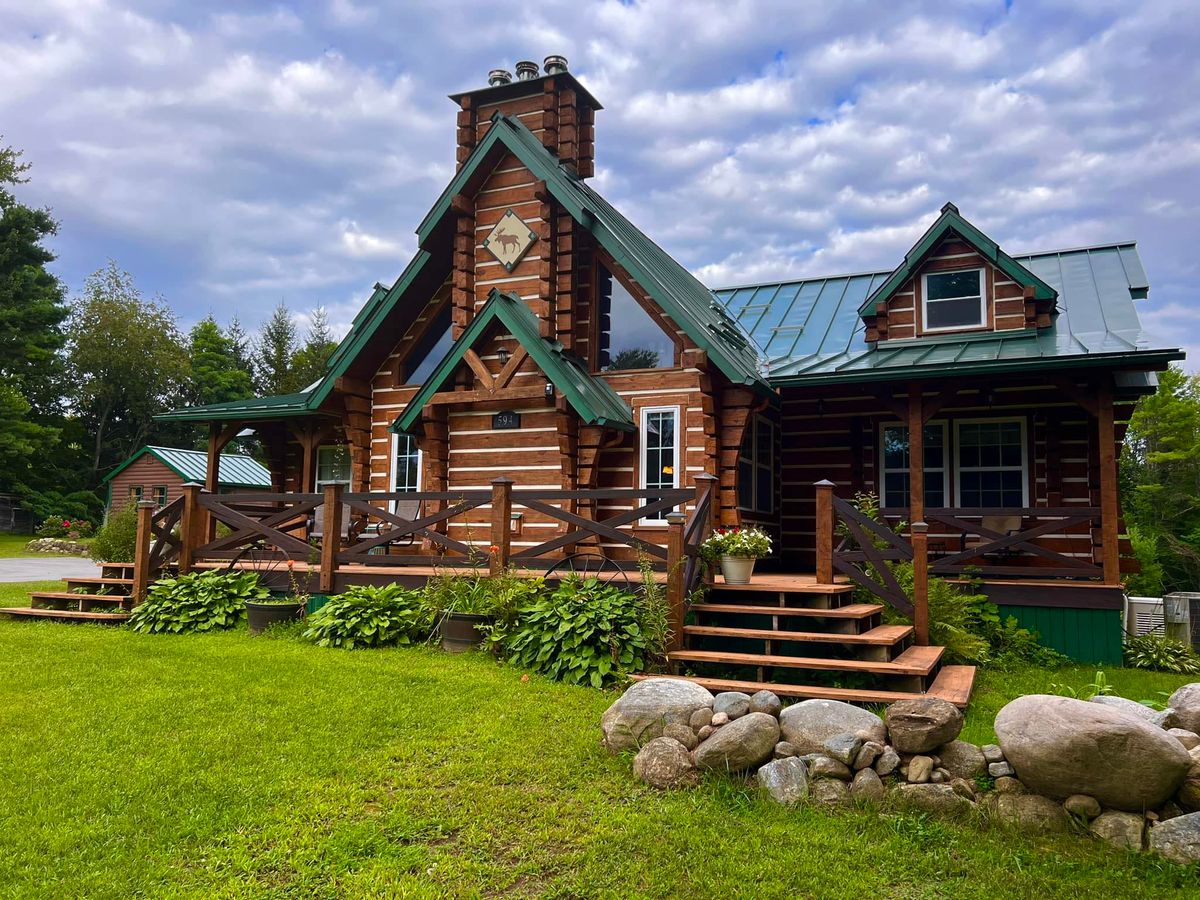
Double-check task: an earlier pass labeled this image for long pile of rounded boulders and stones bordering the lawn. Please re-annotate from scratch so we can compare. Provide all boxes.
[601,678,1200,863]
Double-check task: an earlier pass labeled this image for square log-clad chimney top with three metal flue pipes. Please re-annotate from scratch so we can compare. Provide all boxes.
[450,55,601,178]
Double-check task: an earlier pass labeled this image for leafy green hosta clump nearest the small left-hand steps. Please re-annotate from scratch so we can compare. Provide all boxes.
[130,571,271,634]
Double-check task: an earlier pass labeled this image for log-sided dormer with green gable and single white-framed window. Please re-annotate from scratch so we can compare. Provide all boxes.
[859,203,1058,344]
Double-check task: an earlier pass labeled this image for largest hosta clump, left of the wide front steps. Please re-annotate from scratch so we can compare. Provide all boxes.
[492,577,656,688]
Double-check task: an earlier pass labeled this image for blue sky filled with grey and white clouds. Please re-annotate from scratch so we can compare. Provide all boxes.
[0,0,1200,368]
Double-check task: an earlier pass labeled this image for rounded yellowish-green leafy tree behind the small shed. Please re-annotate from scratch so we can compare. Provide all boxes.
[67,260,187,485]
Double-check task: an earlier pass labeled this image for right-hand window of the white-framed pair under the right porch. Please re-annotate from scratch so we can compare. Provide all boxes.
[954,419,1028,509]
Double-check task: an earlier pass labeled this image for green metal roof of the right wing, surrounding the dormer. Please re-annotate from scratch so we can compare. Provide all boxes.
[715,241,1183,385]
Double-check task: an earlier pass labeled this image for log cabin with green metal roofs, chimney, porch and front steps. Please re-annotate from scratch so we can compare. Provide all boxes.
[14,58,1182,703]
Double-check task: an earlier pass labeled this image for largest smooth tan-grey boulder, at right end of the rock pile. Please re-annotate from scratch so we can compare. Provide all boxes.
[995,694,1192,811]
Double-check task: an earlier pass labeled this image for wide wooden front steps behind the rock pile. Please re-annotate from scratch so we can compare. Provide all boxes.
[667,574,974,707]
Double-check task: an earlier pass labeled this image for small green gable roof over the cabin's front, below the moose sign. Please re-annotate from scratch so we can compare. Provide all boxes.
[391,288,635,432]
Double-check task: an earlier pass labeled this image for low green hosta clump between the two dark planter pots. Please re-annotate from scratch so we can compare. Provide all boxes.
[304,584,433,649]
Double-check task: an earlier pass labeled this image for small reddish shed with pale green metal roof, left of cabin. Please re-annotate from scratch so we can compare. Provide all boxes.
[104,446,271,510]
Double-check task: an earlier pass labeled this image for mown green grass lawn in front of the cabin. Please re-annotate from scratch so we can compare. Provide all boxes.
[0,586,1200,899]
